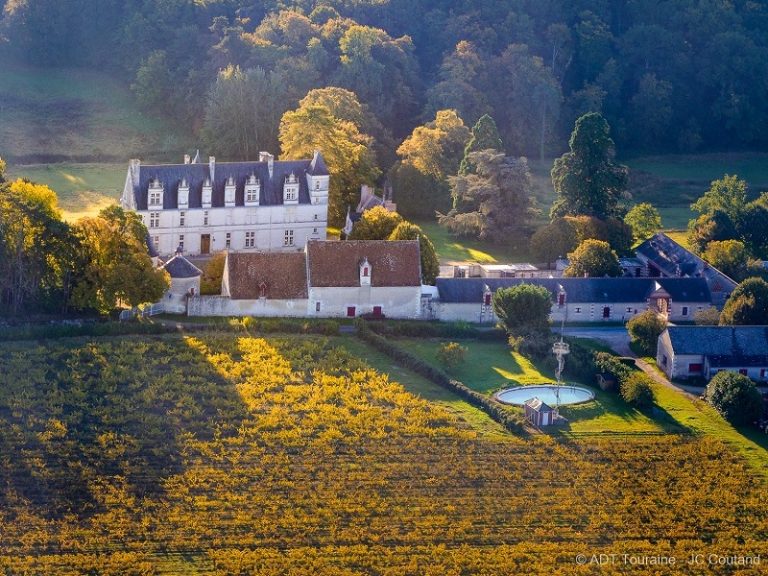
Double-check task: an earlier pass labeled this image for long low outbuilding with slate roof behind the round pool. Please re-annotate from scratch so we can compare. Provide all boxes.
[436,278,711,323]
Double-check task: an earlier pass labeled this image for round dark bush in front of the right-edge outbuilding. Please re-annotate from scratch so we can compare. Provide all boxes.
[706,371,763,425]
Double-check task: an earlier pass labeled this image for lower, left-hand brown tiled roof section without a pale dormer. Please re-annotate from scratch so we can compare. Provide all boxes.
[227,252,307,300]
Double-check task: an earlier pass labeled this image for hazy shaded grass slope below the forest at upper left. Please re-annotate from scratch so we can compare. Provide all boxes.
[0,58,192,163]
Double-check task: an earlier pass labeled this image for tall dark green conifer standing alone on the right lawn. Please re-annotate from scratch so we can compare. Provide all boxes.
[550,113,627,219]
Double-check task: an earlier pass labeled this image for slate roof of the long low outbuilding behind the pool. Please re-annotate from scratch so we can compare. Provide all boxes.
[436,278,711,304]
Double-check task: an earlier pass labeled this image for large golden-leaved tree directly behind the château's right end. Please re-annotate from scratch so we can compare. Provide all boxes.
[280,104,379,226]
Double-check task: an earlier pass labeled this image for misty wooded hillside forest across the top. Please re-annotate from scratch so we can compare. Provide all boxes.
[0,0,768,160]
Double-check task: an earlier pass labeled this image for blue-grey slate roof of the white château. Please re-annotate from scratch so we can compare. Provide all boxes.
[133,153,327,210]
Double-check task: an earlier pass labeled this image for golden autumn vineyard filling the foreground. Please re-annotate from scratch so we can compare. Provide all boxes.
[0,333,768,576]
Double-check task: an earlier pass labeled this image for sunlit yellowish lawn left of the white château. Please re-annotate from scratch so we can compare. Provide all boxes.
[7,162,128,221]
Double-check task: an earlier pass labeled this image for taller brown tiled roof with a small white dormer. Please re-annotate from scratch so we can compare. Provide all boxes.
[307,240,421,287]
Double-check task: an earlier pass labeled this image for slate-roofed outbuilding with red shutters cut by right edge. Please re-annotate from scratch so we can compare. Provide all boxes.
[656,326,768,381]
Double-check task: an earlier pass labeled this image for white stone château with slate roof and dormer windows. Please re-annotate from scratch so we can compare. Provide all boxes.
[120,151,329,256]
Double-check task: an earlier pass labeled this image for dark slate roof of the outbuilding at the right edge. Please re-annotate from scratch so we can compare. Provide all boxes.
[667,326,768,357]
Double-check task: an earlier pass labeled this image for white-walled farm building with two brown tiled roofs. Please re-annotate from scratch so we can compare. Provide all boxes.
[189,240,422,318]
